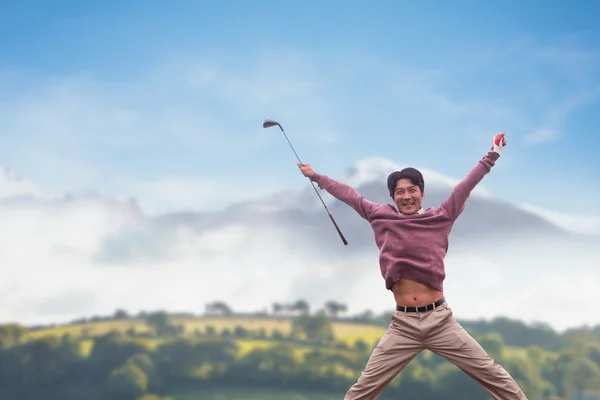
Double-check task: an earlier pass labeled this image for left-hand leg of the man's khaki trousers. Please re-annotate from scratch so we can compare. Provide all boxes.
[344,311,423,400]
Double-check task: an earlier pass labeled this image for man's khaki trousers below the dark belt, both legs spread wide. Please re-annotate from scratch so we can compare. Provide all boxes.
[344,303,527,400]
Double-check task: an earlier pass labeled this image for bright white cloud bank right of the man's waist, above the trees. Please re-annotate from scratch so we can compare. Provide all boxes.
[446,250,600,330]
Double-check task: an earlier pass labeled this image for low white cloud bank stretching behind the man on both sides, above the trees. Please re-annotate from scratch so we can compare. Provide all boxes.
[0,161,600,329]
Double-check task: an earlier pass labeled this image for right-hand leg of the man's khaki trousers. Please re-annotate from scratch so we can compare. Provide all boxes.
[425,303,527,400]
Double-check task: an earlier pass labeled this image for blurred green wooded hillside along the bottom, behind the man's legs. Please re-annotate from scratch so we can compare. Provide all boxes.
[0,302,600,400]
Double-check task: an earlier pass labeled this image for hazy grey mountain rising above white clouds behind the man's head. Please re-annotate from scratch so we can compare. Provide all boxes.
[125,158,577,253]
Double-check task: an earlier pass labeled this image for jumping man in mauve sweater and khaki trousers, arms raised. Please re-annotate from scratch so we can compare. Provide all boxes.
[298,133,527,400]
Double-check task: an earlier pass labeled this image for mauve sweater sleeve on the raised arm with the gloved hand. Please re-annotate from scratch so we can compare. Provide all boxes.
[440,151,500,221]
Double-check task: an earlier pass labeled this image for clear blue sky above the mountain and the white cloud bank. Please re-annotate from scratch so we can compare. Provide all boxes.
[0,1,600,214]
